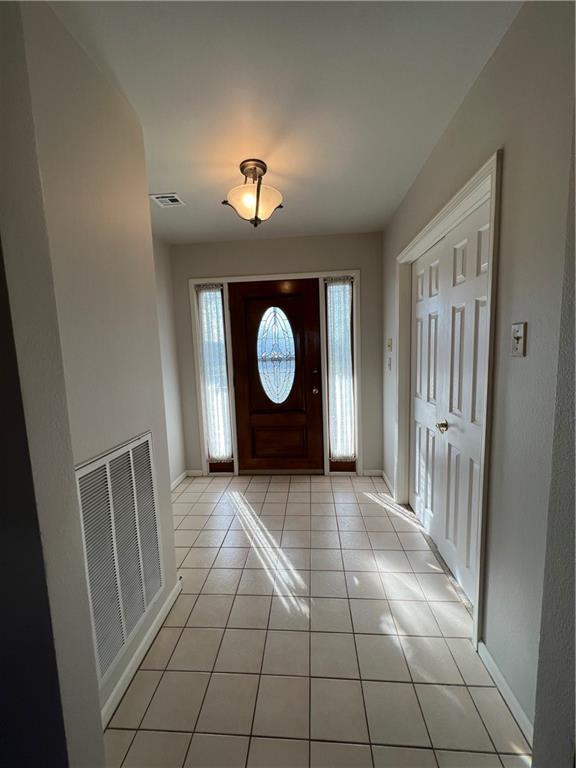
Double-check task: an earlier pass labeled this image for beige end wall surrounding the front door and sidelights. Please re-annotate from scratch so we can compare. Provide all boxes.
[171,232,382,470]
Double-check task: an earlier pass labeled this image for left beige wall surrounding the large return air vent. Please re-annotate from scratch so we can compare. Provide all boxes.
[6,3,176,724]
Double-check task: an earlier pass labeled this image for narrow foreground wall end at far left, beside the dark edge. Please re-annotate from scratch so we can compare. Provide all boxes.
[0,3,104,768]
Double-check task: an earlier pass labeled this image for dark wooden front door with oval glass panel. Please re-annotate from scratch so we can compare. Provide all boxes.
[229,279,323,472]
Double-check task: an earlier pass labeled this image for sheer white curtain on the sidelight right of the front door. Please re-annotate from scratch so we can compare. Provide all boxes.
[326,277,356,461]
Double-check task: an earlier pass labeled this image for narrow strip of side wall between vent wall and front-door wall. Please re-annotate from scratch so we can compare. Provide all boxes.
[154,239,186,482]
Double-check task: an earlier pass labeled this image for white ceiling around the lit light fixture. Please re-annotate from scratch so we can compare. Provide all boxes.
[55,2,519,242]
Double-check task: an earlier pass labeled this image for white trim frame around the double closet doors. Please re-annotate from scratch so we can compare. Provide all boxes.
[394,150,502,647]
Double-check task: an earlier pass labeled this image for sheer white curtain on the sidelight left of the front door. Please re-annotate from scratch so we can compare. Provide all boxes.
[196,285,232,462]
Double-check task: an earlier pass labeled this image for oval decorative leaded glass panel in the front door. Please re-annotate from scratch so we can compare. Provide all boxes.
[256,307,296,403]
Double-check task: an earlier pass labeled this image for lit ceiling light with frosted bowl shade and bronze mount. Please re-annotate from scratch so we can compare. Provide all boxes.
[222,159,284,227]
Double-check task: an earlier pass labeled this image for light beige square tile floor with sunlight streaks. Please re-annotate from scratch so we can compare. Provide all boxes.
[105,476,531,768]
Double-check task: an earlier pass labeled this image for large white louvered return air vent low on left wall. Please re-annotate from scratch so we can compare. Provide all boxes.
[76,433,163,682]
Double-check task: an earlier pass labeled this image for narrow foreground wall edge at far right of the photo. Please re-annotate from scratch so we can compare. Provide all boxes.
[533,153,574,768]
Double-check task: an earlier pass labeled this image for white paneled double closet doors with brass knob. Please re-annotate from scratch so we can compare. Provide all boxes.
[411,203,490,600]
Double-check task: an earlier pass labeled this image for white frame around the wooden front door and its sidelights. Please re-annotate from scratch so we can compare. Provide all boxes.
[188,269,363,475]
